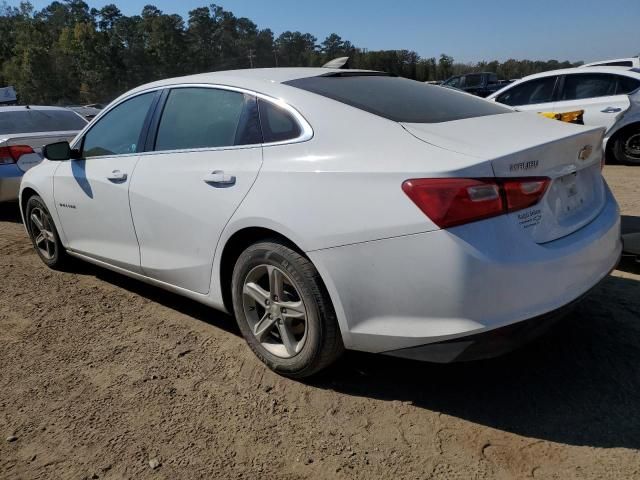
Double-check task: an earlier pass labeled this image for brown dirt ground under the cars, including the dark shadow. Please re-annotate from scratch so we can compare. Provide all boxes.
[0,166,640,479]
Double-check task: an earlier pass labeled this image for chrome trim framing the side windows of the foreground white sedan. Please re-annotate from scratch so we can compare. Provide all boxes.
[72,83,314,158]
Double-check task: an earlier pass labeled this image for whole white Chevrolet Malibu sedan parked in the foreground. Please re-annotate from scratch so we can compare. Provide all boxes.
[20,68,621,377]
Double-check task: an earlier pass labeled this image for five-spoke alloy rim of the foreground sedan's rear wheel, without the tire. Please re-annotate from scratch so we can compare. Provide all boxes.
[242,264,307,358]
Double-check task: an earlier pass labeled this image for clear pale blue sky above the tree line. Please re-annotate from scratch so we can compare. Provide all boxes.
[13,0,640,63]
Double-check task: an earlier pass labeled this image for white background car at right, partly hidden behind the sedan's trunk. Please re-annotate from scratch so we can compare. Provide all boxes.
[487,67,640,165]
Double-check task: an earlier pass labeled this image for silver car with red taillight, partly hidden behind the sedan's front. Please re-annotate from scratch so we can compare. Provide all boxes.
[0,106,87,202]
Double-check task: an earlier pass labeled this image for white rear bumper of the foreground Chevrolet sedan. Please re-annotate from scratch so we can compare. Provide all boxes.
[308,182,622,357]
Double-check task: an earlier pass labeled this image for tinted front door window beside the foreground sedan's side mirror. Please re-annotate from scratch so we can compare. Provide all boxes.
[82,93,155,157]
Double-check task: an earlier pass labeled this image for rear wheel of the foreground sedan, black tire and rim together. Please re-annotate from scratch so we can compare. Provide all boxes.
[232,240,344,378]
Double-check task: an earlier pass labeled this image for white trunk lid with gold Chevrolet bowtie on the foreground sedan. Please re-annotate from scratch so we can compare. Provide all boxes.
[403,113,606,243]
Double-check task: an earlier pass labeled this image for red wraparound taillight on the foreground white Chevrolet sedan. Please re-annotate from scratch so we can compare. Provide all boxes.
[402,177,550,228]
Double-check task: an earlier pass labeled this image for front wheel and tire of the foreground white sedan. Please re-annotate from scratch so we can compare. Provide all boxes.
[24,195,69,270]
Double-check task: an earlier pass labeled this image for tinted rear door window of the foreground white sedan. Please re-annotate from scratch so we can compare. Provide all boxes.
[155,88,260,150]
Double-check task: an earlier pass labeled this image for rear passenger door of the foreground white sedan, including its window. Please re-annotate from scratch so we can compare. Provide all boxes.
[130,86,262,294]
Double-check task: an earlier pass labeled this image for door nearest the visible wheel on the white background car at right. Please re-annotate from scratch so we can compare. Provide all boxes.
[554,73,637,130]
